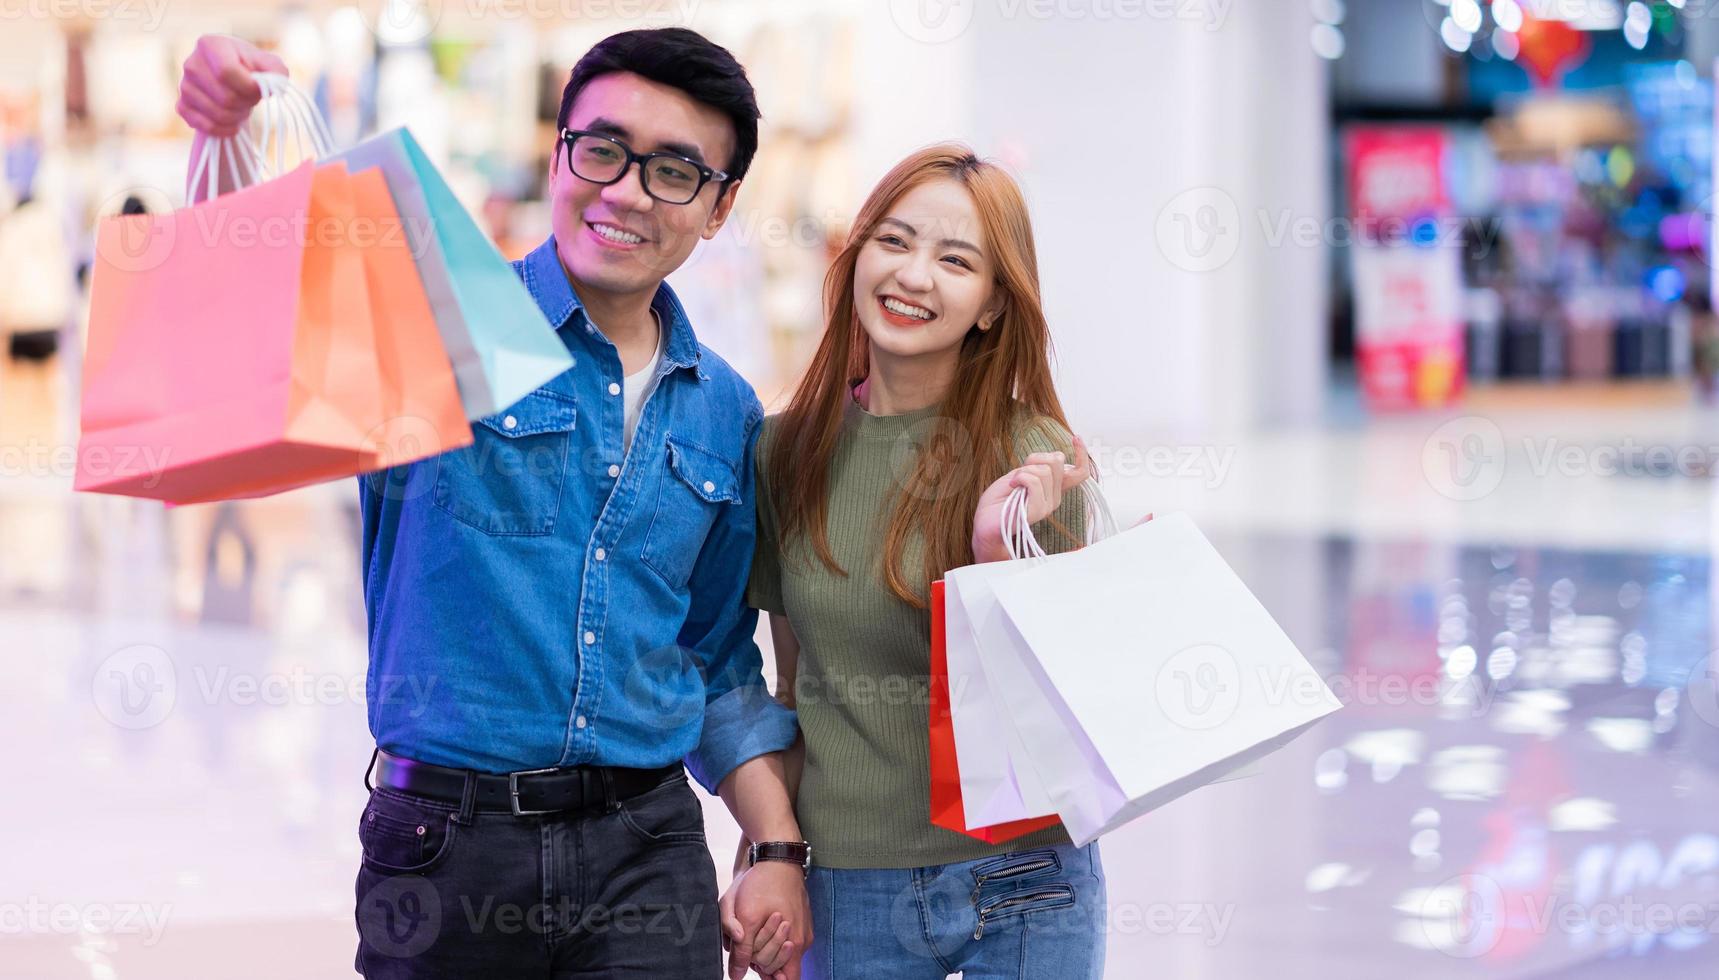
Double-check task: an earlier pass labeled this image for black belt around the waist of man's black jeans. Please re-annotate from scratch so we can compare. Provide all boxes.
[366,748,682,817]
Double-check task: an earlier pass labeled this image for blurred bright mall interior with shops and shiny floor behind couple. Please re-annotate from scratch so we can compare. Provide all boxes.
[0,0,1719,980]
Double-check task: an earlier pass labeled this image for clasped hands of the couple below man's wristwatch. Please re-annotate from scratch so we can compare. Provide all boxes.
[722,861,811,980]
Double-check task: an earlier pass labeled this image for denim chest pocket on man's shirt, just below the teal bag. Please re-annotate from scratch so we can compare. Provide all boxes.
[435,390,578,535]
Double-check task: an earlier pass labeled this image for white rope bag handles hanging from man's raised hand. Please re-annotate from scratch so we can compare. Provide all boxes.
[186,72,333,201]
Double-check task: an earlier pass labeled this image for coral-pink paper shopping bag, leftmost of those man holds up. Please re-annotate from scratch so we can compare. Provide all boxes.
[74,163,409,502]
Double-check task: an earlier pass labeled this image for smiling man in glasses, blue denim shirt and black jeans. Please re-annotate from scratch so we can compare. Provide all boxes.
[179,29,810,978]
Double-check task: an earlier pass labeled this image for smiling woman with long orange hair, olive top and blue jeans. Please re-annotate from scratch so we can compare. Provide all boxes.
[725,144,1105,980]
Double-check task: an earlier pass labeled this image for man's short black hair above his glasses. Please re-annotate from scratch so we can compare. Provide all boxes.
[555,28,760,181]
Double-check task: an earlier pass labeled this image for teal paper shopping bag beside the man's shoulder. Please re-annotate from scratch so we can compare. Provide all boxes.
[333,129,572,420]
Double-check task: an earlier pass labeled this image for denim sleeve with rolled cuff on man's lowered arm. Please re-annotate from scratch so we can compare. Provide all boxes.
[681,402,799,793]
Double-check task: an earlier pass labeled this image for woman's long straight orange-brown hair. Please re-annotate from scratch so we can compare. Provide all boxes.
[765,143,1067,609]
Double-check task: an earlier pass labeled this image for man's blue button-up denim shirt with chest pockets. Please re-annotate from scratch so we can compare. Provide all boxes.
[359,237,796,793]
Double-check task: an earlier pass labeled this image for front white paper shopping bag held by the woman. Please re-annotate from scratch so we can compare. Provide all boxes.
[997,502,1343,844]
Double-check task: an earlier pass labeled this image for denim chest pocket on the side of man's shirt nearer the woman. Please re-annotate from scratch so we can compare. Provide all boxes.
[639,437,741,588]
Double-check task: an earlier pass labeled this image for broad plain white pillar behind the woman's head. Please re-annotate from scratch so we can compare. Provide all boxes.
[854,0,1331,440]
